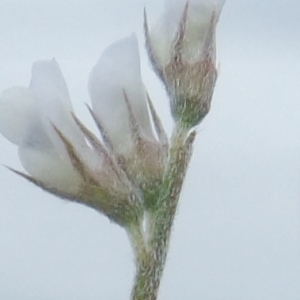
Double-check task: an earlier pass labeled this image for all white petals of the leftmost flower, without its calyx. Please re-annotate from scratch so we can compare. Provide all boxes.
[0,60,85,193]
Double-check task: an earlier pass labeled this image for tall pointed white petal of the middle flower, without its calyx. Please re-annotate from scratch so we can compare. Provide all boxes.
[88,34,153,153]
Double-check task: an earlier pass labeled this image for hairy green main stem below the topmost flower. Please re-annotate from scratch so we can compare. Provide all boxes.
[131,128,195,300]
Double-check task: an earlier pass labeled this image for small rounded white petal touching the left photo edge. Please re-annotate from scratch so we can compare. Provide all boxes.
[0,87,34,144]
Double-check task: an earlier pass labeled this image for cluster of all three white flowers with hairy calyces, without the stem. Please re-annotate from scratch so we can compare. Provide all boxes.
[0,0,224,231]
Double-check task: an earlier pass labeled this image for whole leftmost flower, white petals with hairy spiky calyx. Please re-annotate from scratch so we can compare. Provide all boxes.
[0,60,141,225]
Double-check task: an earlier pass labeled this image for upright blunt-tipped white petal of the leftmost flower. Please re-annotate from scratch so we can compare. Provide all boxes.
[29,59,89,162]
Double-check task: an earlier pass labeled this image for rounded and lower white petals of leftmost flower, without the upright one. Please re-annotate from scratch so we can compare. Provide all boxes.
[0,81,79,192]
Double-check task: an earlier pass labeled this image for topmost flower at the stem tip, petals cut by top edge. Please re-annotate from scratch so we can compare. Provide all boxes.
[145,0,225,128]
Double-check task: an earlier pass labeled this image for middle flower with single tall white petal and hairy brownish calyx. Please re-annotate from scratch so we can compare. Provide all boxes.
[89,34,167,189]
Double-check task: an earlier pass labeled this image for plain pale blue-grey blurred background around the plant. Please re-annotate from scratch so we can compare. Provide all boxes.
[0,0,300,300]
